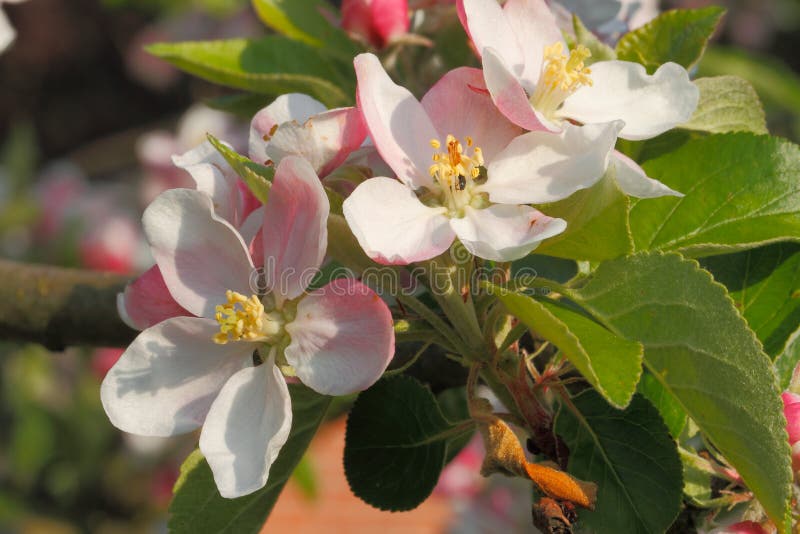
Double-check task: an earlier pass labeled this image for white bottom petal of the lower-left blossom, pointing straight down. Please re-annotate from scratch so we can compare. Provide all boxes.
[200,356,292,499]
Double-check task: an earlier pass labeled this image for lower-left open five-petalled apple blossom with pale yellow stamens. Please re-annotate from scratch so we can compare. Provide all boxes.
[101,157,394,497]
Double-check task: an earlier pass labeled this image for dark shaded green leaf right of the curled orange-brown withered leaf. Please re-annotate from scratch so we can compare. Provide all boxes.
[555,390,683,534]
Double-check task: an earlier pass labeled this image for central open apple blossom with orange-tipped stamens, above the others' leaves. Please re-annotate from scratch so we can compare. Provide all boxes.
[344,54,648,264]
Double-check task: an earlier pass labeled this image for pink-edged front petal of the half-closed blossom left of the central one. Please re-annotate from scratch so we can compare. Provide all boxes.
[266,108,367,177]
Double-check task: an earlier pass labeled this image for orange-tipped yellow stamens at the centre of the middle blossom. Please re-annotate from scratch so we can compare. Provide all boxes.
[428,135,483,217]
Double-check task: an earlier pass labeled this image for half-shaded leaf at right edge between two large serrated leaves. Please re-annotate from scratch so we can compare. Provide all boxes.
[703,243,800,386]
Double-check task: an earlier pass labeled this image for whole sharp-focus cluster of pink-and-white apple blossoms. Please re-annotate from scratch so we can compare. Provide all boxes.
[102,0,698,497]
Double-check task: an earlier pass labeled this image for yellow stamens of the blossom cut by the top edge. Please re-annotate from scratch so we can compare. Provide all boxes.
[530,41,592,118]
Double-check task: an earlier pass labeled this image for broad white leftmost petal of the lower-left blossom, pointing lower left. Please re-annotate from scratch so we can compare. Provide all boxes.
[100,317,255,436]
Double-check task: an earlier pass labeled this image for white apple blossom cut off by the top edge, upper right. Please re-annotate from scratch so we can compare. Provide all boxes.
[459,0,699,140]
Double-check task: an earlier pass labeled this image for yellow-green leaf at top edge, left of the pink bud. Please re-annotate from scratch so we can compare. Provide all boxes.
[253,0,361,61]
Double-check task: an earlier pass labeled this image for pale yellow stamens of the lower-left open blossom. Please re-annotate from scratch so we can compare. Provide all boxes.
[214,290,285,345]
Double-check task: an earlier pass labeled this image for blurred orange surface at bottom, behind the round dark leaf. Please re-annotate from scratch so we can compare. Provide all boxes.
[261,418,454,534]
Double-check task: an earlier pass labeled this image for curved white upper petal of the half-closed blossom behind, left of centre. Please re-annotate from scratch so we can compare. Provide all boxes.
[249,93,327,163]
